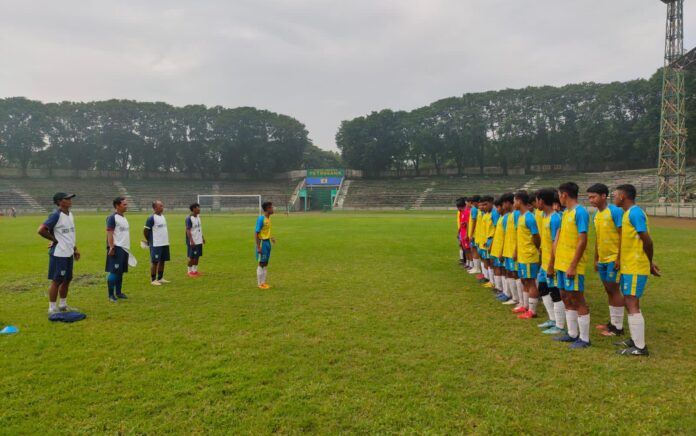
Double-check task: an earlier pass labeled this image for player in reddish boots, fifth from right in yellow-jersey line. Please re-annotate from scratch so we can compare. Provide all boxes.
[513,191,541,319]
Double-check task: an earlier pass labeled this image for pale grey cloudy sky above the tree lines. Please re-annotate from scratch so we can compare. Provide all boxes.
[0,0,696,149]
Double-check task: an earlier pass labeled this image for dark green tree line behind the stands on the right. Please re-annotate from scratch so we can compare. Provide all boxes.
[336,70,696,176]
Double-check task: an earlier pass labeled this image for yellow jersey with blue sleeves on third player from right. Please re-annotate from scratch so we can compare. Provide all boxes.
[554,204,590,275]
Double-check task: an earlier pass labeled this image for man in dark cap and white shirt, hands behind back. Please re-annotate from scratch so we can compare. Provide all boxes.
[38,192,80,315]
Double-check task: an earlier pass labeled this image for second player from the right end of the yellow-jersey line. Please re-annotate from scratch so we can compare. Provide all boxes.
[587,183,624,336]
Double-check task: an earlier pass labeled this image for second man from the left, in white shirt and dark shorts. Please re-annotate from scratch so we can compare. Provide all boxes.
[106,197,130,303]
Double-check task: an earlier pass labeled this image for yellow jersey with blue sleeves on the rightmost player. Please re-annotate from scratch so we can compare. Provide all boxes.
[621,205,650,276]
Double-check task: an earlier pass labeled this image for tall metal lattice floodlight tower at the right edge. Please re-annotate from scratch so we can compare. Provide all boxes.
[657,0,686,203]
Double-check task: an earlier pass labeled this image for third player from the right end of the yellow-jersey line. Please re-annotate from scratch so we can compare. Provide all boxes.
[548,182,591,349]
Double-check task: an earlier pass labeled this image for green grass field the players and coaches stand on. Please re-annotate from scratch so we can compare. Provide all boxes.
[0,213,696,434]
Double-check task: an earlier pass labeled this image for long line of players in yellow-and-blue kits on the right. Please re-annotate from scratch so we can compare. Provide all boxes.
[457,182,660,356]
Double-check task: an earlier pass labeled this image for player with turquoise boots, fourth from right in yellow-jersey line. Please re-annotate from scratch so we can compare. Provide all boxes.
[537,188,565,335]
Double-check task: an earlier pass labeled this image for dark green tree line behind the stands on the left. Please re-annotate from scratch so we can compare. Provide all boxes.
[0,97,338,178]
